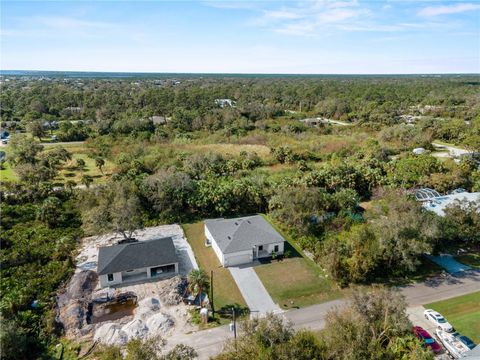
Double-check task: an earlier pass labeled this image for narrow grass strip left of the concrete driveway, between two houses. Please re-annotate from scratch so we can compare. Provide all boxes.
[182,222,246,311]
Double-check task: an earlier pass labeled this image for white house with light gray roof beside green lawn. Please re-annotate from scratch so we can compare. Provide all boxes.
[204,215,285,267]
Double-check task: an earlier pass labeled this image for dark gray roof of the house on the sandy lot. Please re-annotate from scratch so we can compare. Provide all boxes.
[97,237,178,275]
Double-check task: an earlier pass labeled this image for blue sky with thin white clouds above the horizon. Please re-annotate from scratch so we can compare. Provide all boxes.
[0,0,480,74]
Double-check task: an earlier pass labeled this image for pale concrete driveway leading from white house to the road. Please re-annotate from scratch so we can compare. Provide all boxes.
[228,265,282,316]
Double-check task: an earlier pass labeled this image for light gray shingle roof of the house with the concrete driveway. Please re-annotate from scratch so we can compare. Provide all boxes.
[205,215,285,254]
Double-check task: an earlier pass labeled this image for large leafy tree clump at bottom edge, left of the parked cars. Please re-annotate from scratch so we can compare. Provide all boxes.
[321,287,433,360]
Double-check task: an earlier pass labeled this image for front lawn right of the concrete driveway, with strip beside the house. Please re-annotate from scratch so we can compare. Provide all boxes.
[255,217,342,309]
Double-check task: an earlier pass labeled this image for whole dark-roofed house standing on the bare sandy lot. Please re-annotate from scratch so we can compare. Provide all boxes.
[97,237,178,287]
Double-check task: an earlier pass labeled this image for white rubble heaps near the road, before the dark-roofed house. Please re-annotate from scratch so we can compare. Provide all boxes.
[94,297,174,345]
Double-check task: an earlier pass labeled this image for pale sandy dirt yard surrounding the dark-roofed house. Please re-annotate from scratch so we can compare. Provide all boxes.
[57,225,198,345]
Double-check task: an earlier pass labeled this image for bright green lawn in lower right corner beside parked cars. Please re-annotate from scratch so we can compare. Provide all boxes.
[424,291,480,344]
